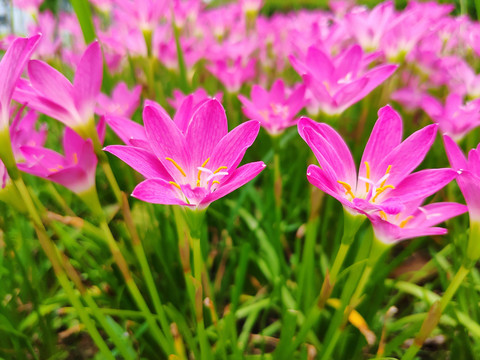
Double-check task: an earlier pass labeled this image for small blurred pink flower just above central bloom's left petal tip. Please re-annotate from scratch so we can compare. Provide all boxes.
[95,82,142,117]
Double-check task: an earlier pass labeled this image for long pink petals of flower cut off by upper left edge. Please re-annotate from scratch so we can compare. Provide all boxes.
[0,35,40,132]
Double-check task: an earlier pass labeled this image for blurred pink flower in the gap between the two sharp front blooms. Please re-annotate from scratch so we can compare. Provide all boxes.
[238,79,305,135]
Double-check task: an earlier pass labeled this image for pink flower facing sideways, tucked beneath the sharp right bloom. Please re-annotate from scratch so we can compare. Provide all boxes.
[369,199,467,244]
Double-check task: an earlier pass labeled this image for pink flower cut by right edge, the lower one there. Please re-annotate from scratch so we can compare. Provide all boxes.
[443,136,480,224]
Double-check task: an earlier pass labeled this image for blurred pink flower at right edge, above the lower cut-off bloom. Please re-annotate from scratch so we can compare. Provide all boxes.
[422,94,480,142]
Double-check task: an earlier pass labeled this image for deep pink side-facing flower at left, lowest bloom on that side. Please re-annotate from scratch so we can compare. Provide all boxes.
[18,128,97,194]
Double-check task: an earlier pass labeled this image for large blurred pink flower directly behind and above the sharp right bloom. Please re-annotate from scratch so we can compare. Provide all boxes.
[290,45,397,115]
